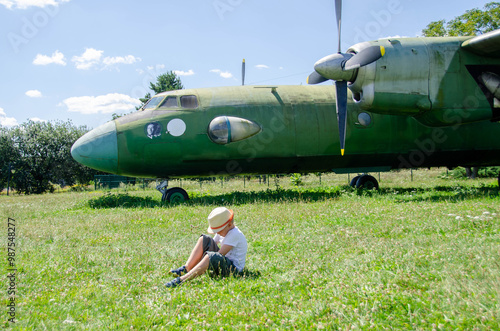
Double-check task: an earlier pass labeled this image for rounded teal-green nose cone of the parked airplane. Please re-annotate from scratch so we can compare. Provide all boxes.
[71,121,118,173]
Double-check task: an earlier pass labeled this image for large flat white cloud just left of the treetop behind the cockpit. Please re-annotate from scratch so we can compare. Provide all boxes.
[60,93,141,115]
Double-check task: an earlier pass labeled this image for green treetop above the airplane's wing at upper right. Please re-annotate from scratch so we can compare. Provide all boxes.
[422,2,500,37]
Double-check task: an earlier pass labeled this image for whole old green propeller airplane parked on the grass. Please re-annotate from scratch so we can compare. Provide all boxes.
[71,1,500,201]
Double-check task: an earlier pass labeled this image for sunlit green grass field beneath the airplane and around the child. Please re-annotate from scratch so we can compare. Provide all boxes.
[0,170,500,330]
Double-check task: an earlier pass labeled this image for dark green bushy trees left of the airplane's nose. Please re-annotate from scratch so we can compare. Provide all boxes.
[0,121,95,194]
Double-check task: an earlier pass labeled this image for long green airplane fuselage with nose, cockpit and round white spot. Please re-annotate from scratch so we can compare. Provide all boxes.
[72,86,500,178]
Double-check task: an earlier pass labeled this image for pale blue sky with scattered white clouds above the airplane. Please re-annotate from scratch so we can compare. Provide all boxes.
[0,0,489,128]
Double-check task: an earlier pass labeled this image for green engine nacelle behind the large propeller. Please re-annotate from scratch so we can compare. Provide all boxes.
[348,37,500,127]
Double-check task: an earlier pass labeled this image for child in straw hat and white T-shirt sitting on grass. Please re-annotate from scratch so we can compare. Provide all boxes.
[165,207,248,288]
